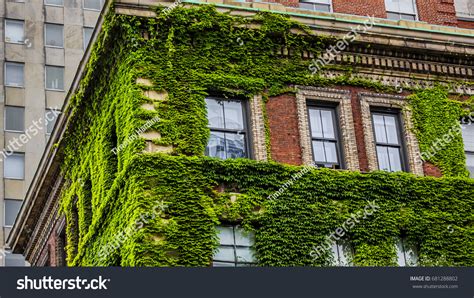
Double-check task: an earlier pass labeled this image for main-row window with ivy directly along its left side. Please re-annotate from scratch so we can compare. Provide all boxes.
[206,98,249,159]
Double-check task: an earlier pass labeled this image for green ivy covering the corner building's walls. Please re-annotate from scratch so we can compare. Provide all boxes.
[58,6,474,266]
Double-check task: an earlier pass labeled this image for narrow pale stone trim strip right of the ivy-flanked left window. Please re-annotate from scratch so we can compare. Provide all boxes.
[249,95,268,161]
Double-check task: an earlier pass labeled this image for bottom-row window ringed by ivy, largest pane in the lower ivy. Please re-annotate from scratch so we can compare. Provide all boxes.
[213,226,256,267]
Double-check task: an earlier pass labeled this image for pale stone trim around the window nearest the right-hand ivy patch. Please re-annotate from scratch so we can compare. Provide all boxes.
[359,93,424,176]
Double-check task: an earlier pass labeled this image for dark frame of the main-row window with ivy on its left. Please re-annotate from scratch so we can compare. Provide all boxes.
[205,96,254,159]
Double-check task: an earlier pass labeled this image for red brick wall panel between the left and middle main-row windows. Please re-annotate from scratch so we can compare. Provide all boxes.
[267,94,303,165]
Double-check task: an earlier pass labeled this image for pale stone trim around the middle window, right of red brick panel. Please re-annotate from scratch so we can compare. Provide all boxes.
[296,86,360,171]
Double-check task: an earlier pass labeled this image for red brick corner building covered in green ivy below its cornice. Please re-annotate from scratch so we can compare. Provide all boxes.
[4,0,474,266]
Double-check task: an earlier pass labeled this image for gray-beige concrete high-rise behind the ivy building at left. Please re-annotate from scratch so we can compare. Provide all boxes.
[0,0,104,266]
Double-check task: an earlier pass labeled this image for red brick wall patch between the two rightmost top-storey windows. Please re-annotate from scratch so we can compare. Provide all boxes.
[417,0,458,26]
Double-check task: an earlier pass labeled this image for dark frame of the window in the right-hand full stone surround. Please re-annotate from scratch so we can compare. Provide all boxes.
[370,107,410,173]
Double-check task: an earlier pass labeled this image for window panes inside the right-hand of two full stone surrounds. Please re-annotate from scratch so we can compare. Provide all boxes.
[372,112,407,172]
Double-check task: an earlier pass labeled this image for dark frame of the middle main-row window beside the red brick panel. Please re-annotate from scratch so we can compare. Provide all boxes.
[306,100,346,170]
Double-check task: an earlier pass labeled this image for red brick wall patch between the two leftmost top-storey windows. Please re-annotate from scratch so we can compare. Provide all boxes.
[332,0,387,18]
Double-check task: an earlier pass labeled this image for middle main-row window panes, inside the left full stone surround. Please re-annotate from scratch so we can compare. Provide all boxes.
[308,106,342,169]
